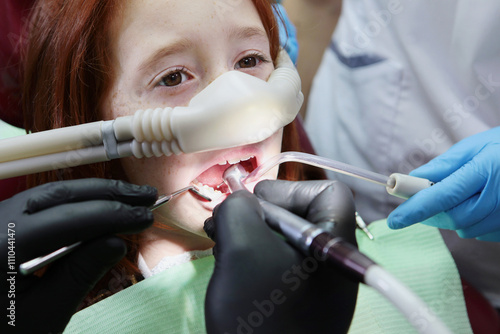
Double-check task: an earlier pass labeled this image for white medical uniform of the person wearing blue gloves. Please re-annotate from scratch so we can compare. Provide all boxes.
[301,0,500,307]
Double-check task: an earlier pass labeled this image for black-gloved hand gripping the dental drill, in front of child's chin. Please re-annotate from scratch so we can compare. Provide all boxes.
[205,181,358,334]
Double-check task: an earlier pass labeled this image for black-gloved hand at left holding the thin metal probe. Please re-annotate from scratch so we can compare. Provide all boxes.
[0,179,157,333]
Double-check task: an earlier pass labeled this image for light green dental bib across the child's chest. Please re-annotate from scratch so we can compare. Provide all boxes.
[64,220,472,334]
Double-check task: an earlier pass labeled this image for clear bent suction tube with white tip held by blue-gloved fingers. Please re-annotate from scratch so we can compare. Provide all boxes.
[244,152,433,199]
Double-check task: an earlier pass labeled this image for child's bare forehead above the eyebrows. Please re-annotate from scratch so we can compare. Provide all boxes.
[110,0,268,71]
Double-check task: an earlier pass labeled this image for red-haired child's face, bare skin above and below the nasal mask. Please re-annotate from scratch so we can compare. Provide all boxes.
[103,0,282,238]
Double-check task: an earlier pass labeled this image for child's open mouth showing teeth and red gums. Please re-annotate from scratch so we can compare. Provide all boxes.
[191,156,258,201]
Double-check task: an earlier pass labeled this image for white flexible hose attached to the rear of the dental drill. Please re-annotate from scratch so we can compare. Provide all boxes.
[365,265,452,334]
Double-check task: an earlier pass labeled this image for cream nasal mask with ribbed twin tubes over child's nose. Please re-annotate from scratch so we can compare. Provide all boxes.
[0,50,304,179]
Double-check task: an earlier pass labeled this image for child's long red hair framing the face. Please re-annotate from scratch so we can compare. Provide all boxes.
[23,0,301,306]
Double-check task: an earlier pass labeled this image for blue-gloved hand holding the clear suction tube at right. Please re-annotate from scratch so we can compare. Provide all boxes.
[387,127,500,241]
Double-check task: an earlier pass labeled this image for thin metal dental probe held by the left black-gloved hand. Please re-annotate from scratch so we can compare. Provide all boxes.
[19,185,212,275]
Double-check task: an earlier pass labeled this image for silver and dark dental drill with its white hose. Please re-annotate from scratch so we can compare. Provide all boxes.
[223,165,452,334]
